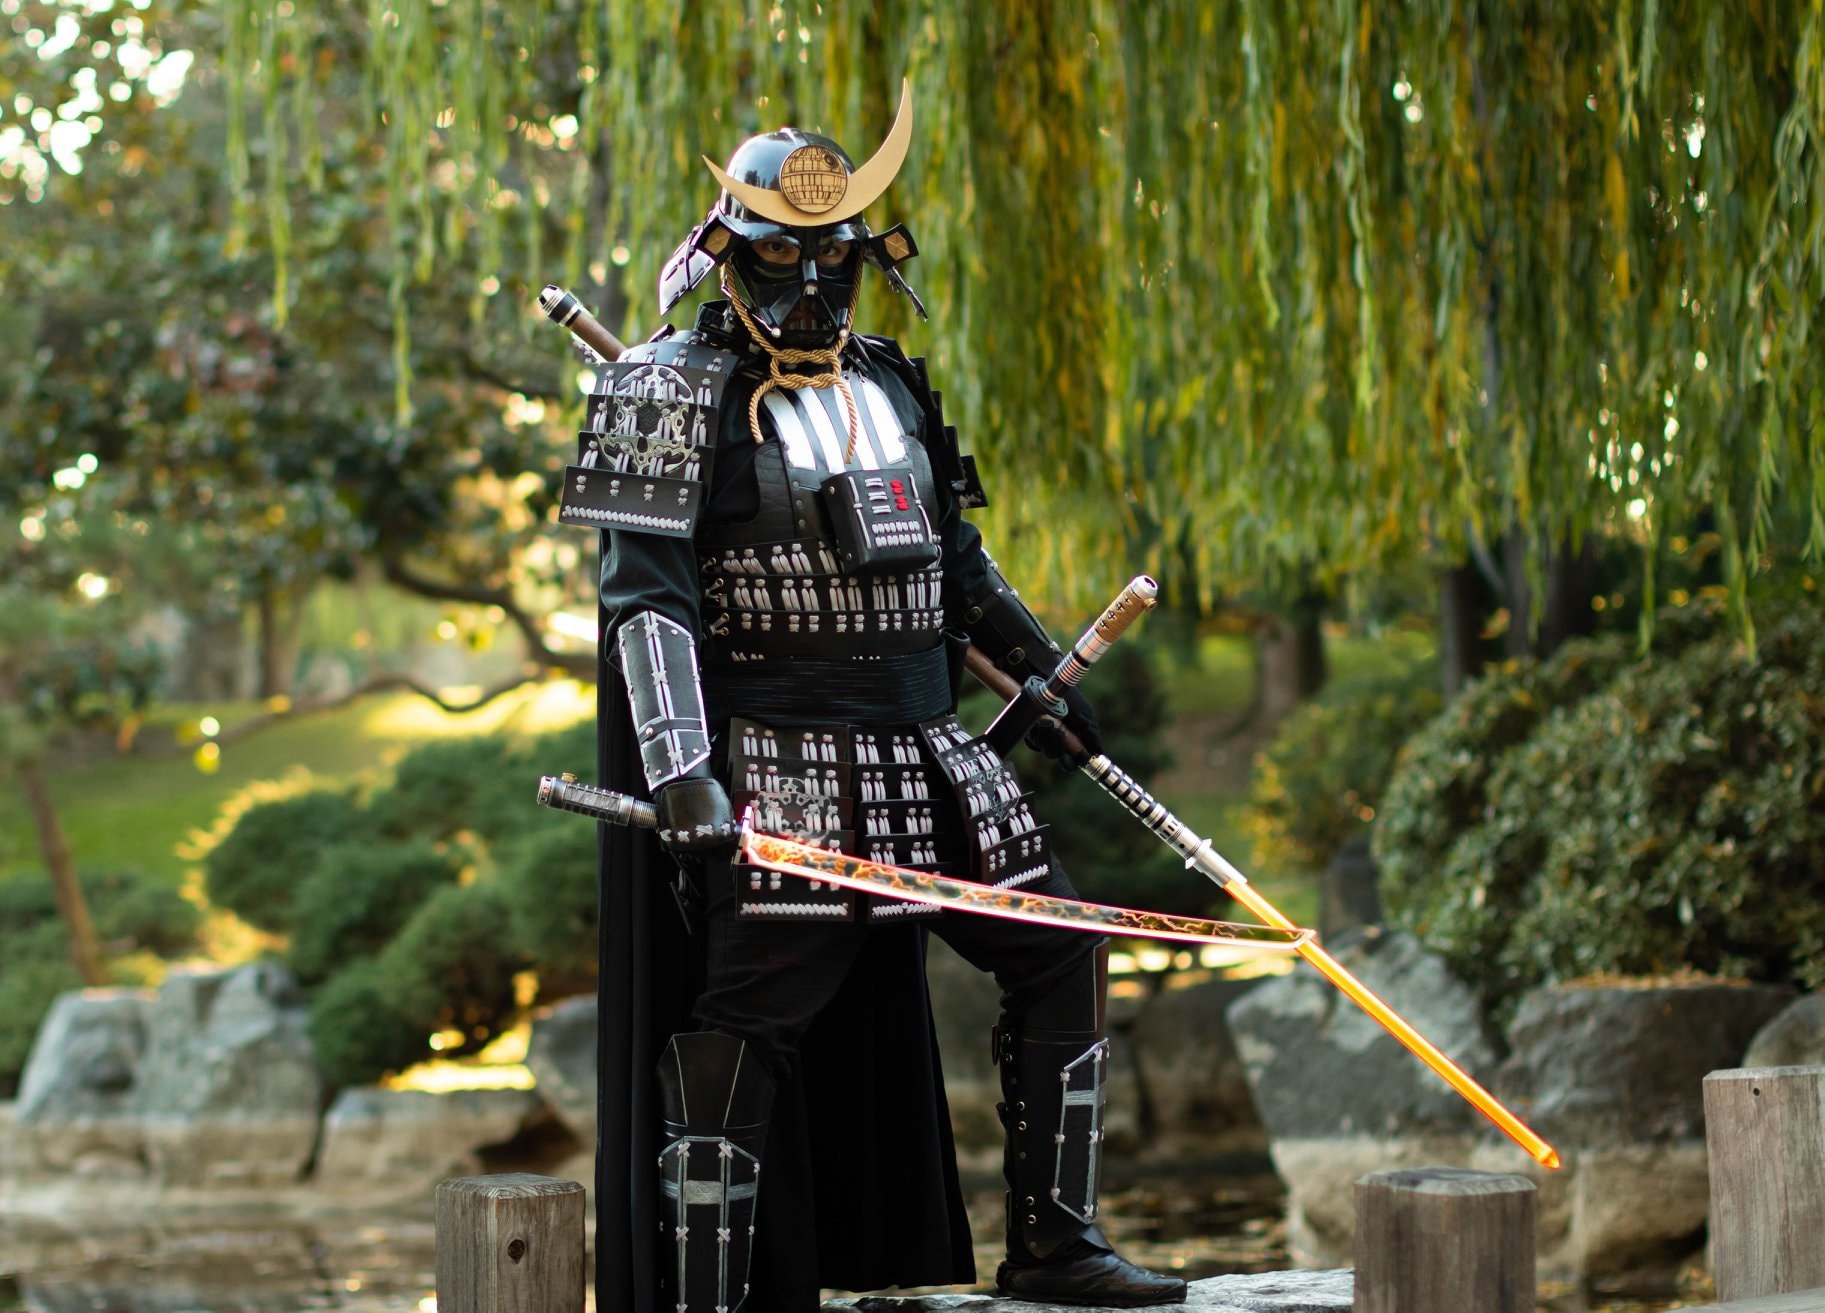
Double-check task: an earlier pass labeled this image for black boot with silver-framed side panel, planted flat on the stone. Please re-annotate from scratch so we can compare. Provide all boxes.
[995,1010,1184,1308]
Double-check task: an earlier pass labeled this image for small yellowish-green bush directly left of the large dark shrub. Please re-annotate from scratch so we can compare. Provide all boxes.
[1248,665,1442,875]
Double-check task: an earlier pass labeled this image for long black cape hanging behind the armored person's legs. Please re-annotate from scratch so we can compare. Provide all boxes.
[595,591,975,1313]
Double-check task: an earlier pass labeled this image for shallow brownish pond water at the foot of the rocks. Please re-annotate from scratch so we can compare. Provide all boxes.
[0,1172,1708,1313]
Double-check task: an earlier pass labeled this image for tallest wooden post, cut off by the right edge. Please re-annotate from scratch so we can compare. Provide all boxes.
[1705,1066,1825,1302]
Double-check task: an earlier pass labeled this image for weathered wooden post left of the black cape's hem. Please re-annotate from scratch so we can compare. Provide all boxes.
[438,1172,584,1313]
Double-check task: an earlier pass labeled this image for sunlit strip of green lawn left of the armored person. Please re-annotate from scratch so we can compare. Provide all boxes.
[0,681,595,884]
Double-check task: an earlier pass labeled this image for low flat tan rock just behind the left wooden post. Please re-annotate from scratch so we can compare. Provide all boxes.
[316,1087,544,1202]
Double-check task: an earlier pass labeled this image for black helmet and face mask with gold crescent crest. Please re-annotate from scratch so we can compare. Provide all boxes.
[659,86,925,347]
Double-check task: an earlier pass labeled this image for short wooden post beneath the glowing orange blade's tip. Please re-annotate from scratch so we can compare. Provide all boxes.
[1356,1167,1535,1313]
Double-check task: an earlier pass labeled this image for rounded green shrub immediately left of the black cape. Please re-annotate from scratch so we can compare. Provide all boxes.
[204,721,597,1083]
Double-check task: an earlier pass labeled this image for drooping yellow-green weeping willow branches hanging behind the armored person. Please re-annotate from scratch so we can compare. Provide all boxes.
[228,0,1825,642]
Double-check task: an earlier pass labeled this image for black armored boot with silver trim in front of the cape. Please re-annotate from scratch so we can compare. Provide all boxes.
[659,1030,774,1313]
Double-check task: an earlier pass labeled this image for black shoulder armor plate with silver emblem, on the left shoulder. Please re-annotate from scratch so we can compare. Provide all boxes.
[558,332,741,539]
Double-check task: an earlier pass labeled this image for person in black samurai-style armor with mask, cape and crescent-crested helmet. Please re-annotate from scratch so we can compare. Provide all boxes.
[584,95,1184,1313]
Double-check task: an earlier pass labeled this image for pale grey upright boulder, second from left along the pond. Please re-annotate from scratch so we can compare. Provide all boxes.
[133,962,323,1189]
